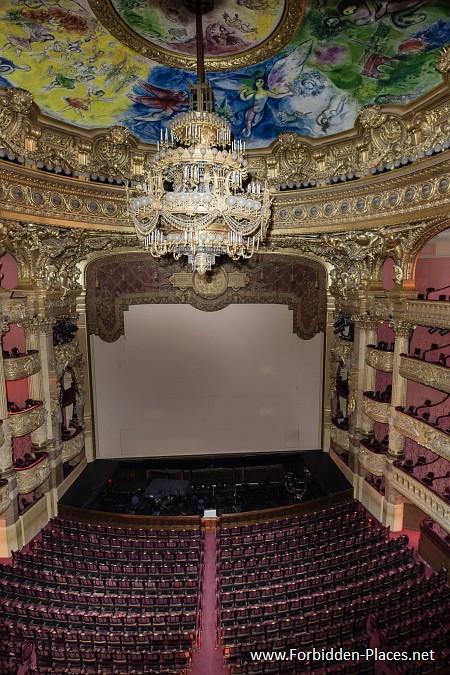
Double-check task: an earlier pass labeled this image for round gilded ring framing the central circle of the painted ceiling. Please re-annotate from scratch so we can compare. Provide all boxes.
[88,0,306,72]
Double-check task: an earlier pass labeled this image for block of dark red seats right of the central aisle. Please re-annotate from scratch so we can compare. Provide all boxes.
[217,502,450,675]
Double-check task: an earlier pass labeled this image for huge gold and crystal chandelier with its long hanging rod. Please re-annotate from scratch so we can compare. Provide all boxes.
[128,0,271,274]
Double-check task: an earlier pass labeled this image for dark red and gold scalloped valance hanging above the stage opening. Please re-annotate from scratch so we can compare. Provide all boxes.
[86,252,326,342]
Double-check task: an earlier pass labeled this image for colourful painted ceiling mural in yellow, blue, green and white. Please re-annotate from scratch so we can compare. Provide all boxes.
[0,0,450,148]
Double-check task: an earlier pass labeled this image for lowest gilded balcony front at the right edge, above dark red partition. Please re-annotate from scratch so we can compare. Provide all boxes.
[391,462,450,532]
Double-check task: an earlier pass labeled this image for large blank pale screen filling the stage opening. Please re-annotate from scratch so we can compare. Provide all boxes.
[91,305,323,459]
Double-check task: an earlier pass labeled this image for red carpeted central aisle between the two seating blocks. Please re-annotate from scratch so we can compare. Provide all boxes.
[191,532,229,675]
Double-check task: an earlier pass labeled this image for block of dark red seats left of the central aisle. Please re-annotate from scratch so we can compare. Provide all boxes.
[0,519,203,675]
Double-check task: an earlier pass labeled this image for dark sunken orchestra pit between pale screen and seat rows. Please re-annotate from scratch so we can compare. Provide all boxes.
[59,450,351,516]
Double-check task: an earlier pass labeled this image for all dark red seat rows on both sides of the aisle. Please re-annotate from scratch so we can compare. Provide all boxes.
[0,500,450,675]
